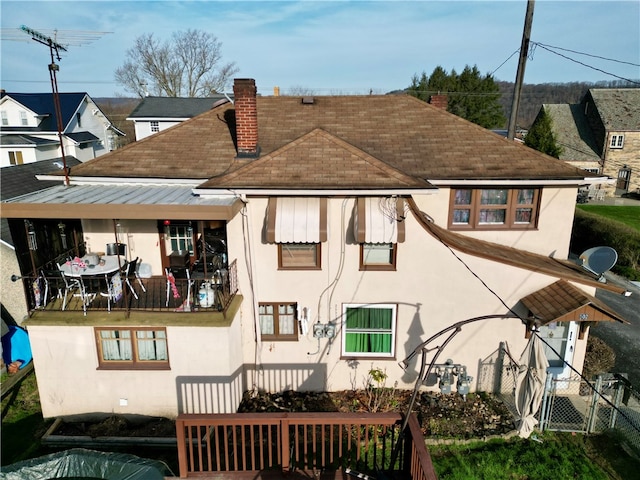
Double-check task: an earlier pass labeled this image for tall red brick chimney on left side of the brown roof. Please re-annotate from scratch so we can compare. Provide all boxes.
[233,78,259,158]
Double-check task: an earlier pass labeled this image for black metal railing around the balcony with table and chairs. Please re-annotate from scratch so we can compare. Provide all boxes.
[21,260,238,313]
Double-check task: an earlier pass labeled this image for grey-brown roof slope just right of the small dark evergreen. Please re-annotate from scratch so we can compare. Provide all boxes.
[542,103,600,163]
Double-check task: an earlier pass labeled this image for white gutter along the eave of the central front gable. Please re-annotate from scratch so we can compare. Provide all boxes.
[193,188,438,197]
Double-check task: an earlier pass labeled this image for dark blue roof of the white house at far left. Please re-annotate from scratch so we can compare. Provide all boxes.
[2,93,87,132]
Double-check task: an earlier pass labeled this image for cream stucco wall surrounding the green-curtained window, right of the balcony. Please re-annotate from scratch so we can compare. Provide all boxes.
[228,191,593,391]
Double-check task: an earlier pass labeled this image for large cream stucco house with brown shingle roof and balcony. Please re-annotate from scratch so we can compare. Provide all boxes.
[1,79,623,417]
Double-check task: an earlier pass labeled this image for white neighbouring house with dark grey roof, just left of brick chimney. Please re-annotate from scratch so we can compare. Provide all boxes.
[127,95,227,140]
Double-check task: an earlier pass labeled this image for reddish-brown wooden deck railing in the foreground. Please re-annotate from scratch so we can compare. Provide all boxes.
[176,413,437,480]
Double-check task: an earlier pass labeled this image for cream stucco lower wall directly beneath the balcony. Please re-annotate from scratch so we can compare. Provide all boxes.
[29,322,243,418]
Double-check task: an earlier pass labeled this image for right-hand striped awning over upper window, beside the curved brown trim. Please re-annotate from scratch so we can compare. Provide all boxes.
[354,197,405,243]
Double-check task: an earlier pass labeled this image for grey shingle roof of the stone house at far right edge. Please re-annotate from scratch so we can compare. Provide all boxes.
[589,88,640,131]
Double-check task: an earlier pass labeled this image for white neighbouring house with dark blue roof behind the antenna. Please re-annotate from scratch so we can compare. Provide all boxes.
[0,91,124,167]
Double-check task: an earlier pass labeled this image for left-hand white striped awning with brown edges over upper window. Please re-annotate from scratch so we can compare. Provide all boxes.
[267,197,327,243]
